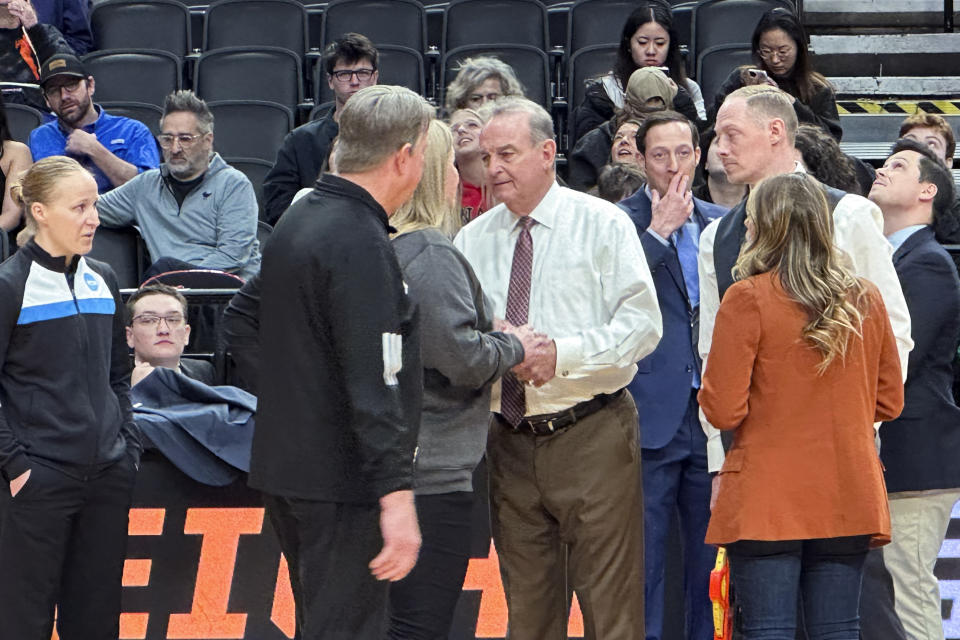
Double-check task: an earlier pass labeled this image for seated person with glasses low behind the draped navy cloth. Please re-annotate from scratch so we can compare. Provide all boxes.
[127,284,216,385]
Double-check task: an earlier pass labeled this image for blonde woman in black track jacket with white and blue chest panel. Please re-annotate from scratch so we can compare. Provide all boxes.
[0,156,141,640]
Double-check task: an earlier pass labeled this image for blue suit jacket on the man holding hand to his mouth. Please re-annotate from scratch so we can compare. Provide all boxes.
[618,189,727,449]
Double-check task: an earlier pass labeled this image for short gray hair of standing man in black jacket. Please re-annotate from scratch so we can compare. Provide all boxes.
[334,84,434,173]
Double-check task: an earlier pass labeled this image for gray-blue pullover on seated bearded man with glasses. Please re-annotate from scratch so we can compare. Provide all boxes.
[97,153,260,279]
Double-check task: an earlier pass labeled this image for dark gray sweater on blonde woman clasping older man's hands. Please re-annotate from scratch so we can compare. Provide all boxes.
[393,229,523,494]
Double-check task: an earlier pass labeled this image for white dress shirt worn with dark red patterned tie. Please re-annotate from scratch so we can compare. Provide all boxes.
[454,184,663,415]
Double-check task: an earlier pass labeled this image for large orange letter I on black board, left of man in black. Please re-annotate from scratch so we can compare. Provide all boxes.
[167,508,263,640]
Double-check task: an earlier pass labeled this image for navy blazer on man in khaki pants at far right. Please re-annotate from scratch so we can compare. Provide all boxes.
[880,227,960,492]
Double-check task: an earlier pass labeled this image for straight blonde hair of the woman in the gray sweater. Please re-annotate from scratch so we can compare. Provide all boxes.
[390,120,460,238]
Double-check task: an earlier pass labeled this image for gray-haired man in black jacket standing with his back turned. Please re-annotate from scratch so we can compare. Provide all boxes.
[228,86,433,640]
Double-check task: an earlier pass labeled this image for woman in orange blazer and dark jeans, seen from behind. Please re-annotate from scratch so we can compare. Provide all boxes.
[700,173,903,640]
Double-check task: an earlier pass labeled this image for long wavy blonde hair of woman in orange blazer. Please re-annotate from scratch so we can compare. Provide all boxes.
[733,173,867,374]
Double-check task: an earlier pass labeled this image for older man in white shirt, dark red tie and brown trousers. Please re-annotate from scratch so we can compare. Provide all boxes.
[454,98,662,640]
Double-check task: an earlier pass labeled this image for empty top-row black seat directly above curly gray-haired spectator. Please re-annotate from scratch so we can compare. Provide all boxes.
[440,0,550,56]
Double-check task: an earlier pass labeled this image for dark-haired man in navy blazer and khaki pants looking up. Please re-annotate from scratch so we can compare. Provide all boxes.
[869,139,960,640]
